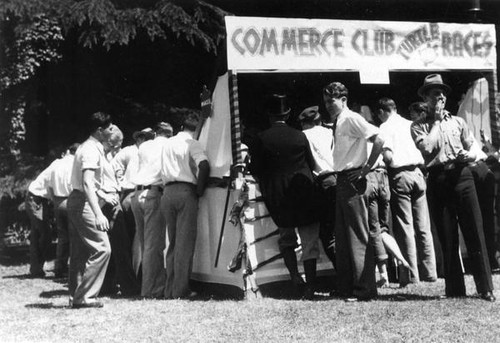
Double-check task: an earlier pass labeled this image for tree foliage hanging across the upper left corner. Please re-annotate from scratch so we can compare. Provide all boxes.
[0,0,227,155]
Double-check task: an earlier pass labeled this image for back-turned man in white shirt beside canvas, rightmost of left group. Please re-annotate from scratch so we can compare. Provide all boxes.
[161,112,210,299]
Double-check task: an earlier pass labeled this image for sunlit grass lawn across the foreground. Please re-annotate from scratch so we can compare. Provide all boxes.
[0,253,500,343]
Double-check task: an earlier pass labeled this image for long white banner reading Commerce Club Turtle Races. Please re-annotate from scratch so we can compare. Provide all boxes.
[225,16,497,72]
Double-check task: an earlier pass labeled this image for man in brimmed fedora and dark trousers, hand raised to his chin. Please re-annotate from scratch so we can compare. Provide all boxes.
[411,74,495,301]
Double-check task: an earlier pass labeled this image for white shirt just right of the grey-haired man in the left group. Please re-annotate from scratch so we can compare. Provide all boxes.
[111,144,139,189]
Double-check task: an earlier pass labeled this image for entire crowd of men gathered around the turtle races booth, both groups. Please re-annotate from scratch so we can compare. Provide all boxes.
[26,74,498,308]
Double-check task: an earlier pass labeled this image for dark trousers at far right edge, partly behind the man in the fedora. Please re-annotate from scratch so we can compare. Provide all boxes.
[469,161,498,269]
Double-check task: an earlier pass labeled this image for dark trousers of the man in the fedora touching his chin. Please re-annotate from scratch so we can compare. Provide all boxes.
[428,167,493,296]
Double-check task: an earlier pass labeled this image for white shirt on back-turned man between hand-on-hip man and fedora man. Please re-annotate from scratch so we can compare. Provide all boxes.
[380,113,424,168]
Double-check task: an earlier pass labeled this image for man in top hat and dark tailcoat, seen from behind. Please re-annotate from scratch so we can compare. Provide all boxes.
[250,94,319,299]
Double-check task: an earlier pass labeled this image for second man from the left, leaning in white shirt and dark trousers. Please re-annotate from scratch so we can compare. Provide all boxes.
[49,143,80,278]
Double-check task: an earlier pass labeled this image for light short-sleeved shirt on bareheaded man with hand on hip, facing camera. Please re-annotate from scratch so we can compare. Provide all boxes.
[333,108,379,171]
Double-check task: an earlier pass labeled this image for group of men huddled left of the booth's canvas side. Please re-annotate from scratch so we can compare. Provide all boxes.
[26,112,210,308]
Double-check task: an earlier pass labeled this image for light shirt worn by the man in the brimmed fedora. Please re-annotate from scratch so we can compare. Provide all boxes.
[411,112,474,167]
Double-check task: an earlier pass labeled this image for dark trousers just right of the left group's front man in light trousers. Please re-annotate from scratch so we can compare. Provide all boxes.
[101,203,140,295]
